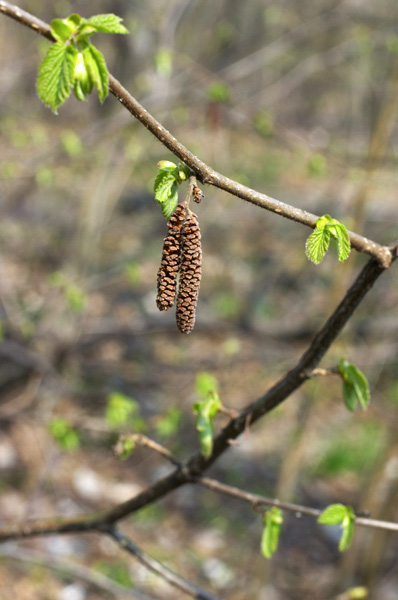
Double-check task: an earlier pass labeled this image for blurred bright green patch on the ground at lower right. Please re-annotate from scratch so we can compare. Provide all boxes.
[314,422,386,477]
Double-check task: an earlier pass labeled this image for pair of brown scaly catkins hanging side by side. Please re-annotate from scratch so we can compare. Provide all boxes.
[156,202,202,333]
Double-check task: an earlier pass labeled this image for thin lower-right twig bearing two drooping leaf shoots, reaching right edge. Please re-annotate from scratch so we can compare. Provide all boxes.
[196,477,398,532]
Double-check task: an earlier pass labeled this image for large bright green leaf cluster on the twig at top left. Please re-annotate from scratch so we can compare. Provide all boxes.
[37,14,128,113]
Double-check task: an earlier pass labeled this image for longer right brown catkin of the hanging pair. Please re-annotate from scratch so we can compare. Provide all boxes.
[177,213,202,333]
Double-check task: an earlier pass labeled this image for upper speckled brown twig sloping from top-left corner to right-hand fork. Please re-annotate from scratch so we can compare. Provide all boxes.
[0,0,392,268]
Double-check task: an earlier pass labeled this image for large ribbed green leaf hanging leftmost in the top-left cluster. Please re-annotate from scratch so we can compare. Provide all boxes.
[37,42,78,114]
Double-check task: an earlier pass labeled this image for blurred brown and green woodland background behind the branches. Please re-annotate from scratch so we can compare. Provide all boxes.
[0,0,398,600]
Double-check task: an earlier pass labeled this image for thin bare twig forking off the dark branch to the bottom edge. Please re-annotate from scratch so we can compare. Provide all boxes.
[103,527,220,600]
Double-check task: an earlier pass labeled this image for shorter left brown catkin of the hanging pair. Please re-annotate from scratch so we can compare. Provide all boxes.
[156,202,186,310]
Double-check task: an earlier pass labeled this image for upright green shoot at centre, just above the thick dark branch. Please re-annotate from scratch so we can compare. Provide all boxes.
[192,372,222,458]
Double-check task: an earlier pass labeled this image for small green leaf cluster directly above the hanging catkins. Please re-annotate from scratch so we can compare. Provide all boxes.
[154,160,190,220]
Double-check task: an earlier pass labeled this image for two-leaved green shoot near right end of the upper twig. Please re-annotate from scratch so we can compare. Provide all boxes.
[305,215,351,265]
